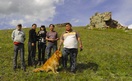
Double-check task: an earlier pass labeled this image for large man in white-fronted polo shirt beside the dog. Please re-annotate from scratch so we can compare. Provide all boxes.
[58,23,82,73]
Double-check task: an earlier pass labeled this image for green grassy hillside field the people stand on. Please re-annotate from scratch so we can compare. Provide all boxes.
[0,27,132,81]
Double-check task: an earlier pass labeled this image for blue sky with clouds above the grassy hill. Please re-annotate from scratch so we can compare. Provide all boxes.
[0,0,132,29]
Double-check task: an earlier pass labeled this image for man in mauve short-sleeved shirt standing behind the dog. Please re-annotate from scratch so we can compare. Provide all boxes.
[46,24,59,59]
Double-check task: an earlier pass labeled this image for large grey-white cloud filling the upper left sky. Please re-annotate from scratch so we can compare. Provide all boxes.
[0,0,63,26]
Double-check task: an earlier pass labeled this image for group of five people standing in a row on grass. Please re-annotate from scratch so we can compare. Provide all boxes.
[11,23,82,73]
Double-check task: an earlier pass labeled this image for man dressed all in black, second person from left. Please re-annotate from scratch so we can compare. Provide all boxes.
[28,24,37,67]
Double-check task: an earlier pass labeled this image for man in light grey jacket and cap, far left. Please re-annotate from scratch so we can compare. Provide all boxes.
[11,24,26,71]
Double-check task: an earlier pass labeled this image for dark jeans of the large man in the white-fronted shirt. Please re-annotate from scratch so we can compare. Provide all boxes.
[62,48,78,71]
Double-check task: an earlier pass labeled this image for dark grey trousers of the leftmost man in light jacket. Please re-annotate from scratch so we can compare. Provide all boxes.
[13,43,25,69]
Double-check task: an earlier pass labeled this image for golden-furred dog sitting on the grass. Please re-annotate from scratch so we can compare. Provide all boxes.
[33,50,62,74]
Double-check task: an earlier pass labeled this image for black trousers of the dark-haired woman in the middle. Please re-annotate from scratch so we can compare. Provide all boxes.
[38,42,46,62]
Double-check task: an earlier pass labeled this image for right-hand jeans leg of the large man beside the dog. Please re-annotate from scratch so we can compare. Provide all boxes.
[70,49,78,73]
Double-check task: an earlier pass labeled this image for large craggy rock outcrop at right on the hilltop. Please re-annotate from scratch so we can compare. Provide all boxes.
[88,12,123,29]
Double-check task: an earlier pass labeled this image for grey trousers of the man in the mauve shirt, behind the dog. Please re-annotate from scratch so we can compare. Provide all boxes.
[46,43,57,59]
